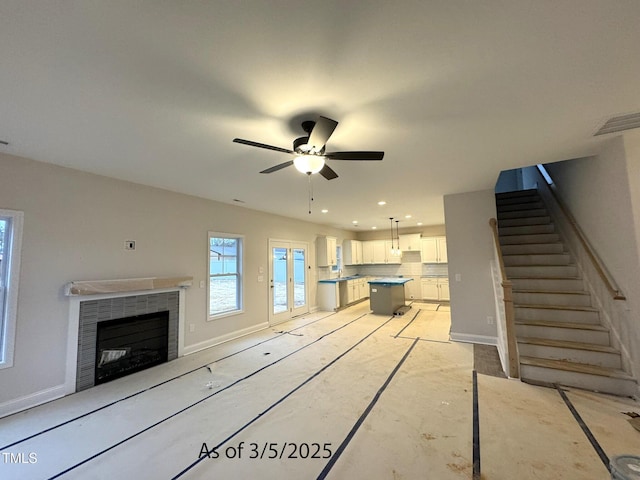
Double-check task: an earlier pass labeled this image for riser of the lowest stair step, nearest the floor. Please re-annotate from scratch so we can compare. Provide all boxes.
[520,365,637,396]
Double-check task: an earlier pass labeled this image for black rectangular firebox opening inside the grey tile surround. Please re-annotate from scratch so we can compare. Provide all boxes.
[95,310,169,385]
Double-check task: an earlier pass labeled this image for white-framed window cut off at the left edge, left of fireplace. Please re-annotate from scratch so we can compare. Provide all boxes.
[0,210,23,368]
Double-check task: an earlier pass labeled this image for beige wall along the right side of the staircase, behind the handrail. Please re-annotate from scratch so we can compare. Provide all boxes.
[545,130,640,378]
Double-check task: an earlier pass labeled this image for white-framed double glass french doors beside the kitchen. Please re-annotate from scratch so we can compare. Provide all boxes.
[269,240,309,325]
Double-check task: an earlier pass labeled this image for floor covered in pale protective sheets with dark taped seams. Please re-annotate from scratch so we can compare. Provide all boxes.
[0,302,640,480]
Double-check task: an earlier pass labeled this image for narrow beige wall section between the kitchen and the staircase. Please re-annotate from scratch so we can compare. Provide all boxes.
[444,190,497,344]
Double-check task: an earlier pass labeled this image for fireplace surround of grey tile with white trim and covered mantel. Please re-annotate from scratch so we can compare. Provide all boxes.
[65,277,193,394]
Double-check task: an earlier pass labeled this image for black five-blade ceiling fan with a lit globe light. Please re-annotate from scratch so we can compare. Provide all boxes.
[233,116,384,180]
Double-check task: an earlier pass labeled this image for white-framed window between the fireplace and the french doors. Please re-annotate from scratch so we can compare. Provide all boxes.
[209,232,243,319]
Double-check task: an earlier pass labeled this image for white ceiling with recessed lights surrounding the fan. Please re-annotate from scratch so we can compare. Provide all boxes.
[0,0,640,230]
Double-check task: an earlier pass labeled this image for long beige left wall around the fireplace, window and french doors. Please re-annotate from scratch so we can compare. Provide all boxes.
[0,154,353,415]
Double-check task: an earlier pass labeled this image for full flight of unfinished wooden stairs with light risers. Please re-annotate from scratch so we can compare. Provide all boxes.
[496,190,636,396]
